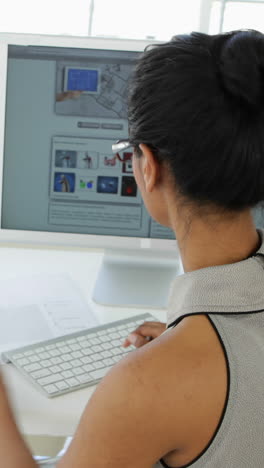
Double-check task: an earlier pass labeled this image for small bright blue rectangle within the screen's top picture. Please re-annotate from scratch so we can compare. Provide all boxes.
[67,68,98,93]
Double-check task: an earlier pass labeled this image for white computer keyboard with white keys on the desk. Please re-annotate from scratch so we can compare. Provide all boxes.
[2,314,156,398]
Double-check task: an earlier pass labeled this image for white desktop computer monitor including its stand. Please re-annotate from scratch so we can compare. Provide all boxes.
[0,34,181,308]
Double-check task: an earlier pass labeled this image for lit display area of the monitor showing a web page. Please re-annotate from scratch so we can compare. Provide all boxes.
[1,37,174,239]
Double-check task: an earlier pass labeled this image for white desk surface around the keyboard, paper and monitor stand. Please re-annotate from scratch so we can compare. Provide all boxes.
[0,246,166,435]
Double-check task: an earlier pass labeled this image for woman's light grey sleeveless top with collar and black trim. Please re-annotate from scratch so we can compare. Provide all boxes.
[154,230,264,468]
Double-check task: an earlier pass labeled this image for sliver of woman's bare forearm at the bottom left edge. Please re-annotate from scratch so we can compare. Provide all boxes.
[0,377,37,468]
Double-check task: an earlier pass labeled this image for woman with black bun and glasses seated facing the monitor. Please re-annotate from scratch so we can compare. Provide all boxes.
[0,31,264,468]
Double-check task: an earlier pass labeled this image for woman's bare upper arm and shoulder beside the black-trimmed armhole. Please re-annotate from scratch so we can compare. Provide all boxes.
[58,315,227,468]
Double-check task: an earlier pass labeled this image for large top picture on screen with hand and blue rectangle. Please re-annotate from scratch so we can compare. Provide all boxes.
[55,57,134,119]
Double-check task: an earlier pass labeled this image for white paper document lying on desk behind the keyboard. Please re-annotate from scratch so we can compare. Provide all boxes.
[0,274,98,353]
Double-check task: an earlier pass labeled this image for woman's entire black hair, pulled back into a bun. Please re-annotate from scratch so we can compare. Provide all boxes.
[128,30,264,211]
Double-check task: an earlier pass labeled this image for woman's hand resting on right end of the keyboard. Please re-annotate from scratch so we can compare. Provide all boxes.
[123,322,166,348]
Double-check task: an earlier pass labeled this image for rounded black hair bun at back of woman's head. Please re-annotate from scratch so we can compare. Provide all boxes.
[219,30,264,109]
